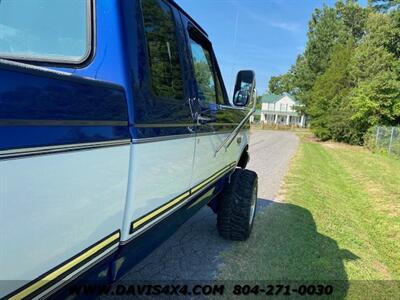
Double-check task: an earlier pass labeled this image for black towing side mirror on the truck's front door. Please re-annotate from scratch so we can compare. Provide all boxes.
[233,71,256,107]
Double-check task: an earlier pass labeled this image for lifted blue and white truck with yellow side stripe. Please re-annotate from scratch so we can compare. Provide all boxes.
[0,0,257,299]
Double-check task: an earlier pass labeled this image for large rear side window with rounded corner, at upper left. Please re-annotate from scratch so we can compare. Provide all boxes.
[0,0,91,63]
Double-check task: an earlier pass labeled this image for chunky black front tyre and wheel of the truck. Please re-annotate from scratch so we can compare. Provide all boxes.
[217,169,258,241]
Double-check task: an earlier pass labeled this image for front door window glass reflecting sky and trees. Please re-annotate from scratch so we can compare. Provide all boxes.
[190,39,217,104]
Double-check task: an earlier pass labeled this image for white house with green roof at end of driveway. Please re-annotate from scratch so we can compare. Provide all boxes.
[253,93,306,127]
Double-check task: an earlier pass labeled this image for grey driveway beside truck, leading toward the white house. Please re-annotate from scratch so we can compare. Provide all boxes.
[119,131,299,282]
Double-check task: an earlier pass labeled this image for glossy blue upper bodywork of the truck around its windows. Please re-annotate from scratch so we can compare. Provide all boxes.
[0,0,245,150]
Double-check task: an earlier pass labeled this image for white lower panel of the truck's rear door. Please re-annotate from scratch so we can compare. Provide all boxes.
[122,137,195,241]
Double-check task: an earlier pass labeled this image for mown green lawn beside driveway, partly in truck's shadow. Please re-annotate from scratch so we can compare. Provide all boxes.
[219,134,400,299]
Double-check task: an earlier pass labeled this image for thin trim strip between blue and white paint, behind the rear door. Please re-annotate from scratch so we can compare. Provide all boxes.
[0,139,131,160]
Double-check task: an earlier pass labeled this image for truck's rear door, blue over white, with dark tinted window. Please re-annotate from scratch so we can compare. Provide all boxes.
[122,0,195,240]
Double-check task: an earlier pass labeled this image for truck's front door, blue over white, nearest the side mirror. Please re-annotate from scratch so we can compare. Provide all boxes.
[183,16,245,192]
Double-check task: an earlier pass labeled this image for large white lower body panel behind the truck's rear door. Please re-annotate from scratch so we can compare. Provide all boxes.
[0,145,130,297]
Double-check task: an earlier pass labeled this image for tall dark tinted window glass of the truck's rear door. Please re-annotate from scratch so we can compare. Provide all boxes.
[142,0,183,99]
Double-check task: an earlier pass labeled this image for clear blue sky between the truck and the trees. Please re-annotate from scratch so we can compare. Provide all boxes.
[175,0,367,95]
